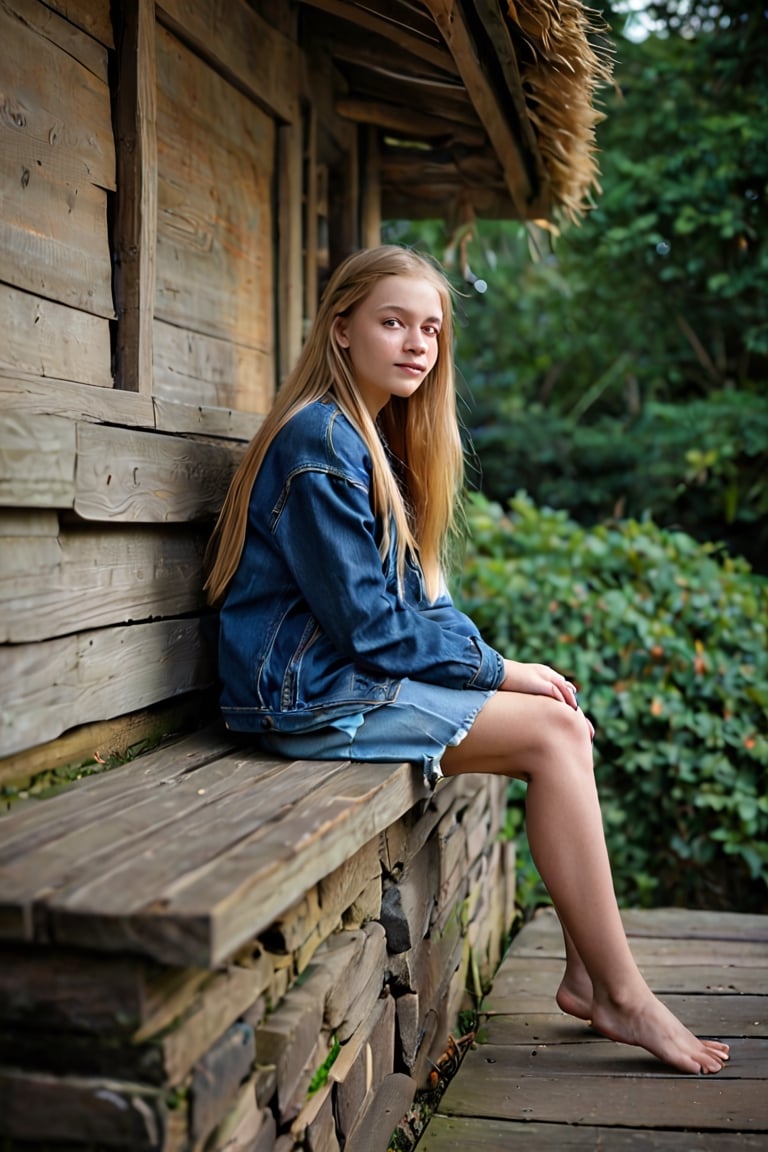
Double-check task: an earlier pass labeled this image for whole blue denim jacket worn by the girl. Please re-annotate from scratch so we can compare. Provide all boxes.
[219,400,504,732]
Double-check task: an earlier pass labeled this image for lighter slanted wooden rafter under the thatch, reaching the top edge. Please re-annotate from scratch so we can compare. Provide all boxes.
[424,0,543,220]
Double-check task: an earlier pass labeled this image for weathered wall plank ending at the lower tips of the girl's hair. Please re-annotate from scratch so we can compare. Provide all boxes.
[0,517,207,643]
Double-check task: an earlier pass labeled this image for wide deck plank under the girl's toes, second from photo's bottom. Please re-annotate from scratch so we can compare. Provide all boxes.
[440,1041,768,1132]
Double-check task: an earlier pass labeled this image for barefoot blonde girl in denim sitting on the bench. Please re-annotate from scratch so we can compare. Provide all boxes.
[207,247,728,1073]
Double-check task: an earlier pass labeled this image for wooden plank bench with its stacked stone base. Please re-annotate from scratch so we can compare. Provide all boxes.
[0,729,514,1152]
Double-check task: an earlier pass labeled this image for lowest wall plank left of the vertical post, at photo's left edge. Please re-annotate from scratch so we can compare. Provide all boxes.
[0,283,112,388]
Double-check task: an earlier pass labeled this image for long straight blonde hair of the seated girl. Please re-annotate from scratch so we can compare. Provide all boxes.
[205,244,463,604]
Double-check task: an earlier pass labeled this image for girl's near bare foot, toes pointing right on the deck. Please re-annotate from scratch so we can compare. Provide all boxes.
[594,987,729,1073]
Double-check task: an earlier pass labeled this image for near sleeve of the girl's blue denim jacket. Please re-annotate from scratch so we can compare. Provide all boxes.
[273,469,504,689]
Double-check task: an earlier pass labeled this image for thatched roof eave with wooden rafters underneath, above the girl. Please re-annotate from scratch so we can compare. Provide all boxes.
[301,0,610,220]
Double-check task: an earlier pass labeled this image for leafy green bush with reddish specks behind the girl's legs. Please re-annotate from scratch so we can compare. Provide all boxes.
[455,495,768,911]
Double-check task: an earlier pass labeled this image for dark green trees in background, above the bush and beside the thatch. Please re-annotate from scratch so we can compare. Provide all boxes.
[387,0,768,564]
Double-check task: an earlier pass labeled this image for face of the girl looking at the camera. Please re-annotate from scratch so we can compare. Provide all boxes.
[335,276,442,419]
